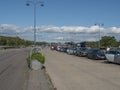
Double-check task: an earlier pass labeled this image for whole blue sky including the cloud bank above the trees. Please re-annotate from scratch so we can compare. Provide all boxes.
[0,0,120,42]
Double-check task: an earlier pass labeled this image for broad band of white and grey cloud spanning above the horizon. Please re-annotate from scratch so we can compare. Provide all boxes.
[0,24,120,41]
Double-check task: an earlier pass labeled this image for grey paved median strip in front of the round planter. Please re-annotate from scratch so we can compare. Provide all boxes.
[23,69,56,90]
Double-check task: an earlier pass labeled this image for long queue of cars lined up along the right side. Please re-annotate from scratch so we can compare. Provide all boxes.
[51,46,120,64]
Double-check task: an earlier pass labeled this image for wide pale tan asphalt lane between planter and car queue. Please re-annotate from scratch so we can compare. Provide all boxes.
[43,48,120,90]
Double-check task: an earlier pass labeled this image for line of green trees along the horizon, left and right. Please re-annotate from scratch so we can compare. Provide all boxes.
[0,36,120,48]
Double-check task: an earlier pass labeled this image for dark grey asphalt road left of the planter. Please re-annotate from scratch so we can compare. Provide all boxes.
[0,49,29,90]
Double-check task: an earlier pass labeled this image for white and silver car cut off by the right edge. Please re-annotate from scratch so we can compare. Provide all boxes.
[105,50,120,64]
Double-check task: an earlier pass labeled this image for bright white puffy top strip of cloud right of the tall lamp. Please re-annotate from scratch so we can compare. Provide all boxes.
[37,25,107,33]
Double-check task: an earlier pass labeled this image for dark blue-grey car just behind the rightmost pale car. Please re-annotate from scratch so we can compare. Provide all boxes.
[87,49,106,60]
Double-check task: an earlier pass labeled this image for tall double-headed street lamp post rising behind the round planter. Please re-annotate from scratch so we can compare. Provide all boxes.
[26,0,44,46]
